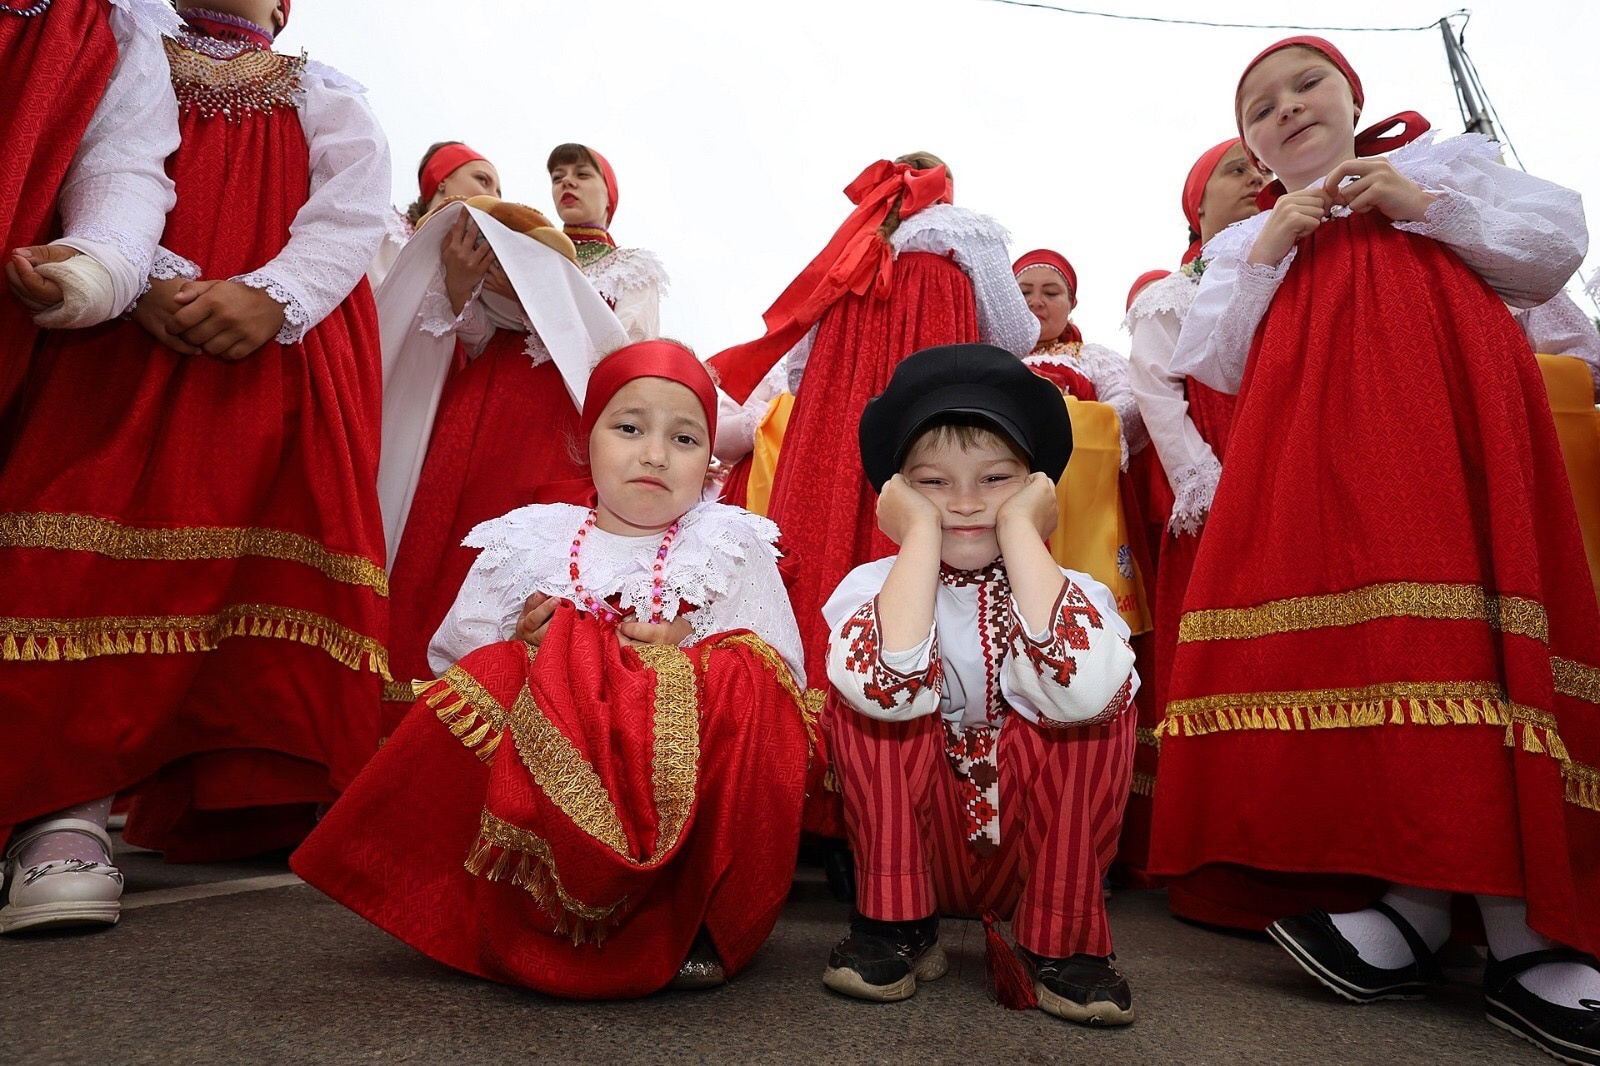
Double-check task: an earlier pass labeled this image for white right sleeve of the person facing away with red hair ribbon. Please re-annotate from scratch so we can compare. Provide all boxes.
[890,203,1038,359]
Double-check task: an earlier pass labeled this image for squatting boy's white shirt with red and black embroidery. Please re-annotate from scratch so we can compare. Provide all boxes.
[822,555,1139,727]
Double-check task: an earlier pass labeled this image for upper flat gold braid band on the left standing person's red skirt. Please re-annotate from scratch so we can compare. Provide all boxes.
[0,512,389,597]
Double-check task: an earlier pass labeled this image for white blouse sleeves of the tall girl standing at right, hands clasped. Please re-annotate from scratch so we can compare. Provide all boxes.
[1171,133,1589,392]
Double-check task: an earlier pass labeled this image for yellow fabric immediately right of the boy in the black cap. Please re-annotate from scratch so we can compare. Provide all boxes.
[1049,397,1150,634]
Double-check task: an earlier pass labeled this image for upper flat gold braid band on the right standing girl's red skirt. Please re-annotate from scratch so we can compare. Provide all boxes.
[1178,581,1550,643]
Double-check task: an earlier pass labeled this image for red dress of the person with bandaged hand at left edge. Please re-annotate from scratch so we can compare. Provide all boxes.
[0,0,117,448]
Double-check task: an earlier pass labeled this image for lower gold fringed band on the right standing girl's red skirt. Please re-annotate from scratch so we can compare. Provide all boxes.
[1157,682,1600,812]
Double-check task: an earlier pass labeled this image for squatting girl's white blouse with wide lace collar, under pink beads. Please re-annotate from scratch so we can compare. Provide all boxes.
[427,503,805,687]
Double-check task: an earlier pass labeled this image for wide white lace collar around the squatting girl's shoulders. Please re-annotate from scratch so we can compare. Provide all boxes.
[462,503,778,635]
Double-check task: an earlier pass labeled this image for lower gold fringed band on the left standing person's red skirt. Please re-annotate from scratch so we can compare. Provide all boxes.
[0,603,392,680]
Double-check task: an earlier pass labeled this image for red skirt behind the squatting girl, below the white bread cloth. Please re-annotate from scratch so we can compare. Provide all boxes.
[382,330,586,736]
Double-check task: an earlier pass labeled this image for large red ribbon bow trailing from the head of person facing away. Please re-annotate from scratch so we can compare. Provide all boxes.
[706,158,955,403]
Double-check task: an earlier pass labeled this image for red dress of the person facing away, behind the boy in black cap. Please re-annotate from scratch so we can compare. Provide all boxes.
[768,251,978,837]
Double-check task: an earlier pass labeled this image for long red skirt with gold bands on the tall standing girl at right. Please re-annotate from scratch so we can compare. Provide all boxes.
[1152,214,1600,951]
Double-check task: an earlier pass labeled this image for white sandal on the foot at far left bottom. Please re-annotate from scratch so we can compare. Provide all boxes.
[0,818,122,933]
